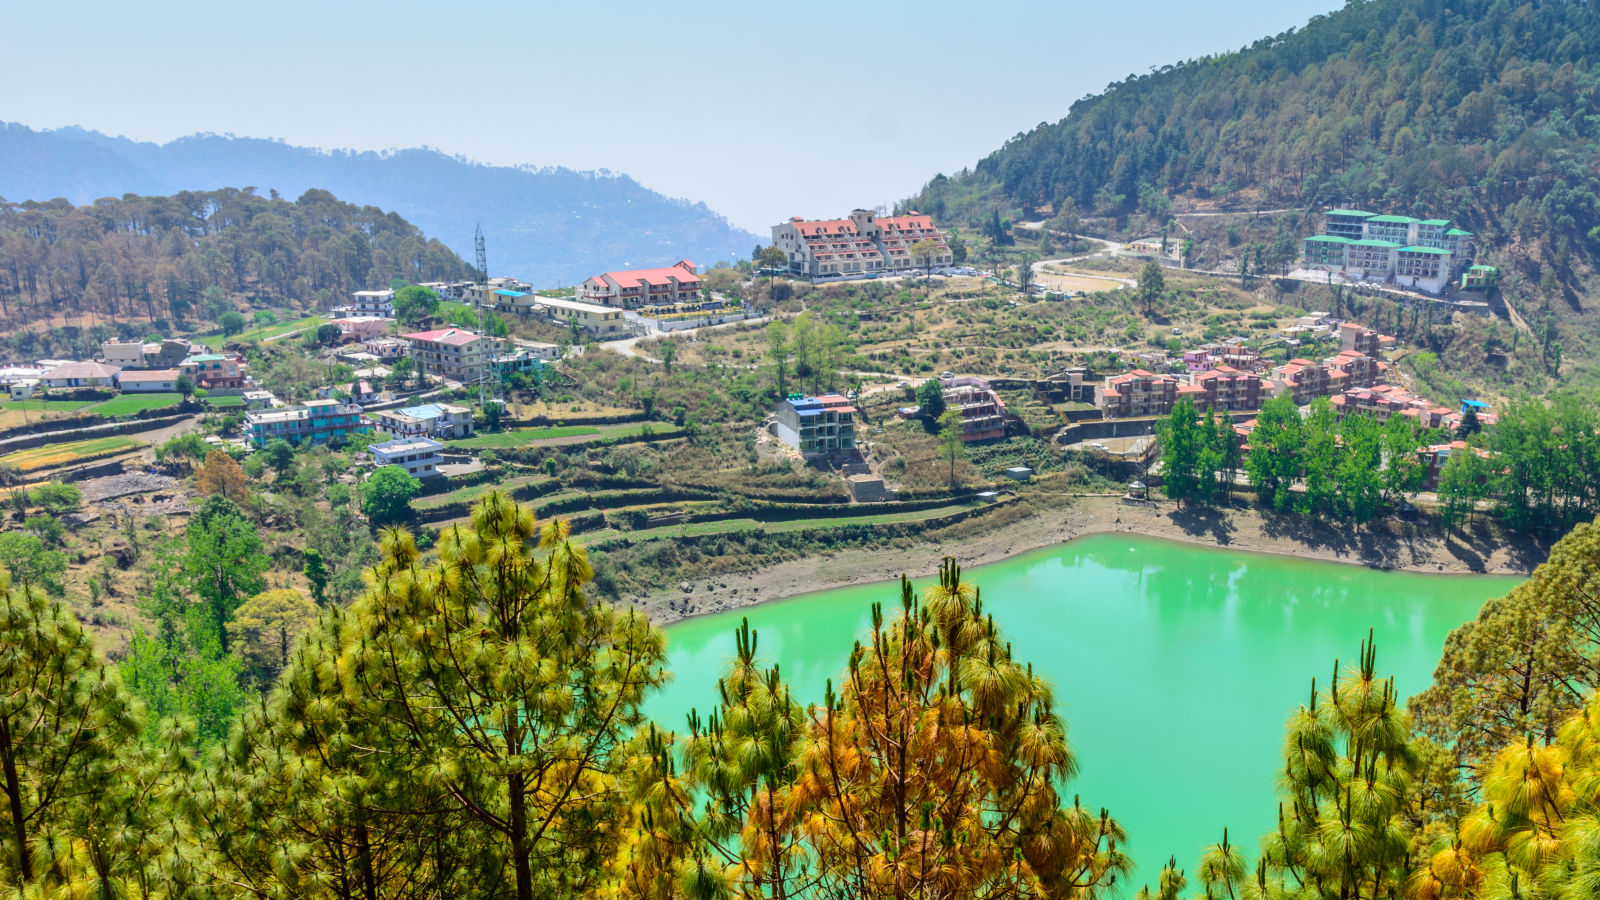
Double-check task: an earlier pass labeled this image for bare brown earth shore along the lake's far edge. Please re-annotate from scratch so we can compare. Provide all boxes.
[640,496,1549,625]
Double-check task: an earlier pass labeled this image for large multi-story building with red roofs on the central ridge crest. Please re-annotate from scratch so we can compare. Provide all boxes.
[773,210,954,279]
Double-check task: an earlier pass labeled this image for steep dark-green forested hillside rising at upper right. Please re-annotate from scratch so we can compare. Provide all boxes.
[910,0,1600,269]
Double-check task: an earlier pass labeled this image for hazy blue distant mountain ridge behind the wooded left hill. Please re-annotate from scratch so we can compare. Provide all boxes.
[0,123,760,285]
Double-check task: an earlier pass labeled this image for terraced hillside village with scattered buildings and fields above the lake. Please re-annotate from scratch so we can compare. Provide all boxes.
[0,198,1529,630]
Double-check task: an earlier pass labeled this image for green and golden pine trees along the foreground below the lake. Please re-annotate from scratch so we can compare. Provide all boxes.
[0,492,1600,900]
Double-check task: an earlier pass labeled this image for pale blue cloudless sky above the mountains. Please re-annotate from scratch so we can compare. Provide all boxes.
[0,0,1336,234]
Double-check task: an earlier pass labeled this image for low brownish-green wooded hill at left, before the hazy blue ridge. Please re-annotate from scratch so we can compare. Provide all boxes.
[0,187,469,331]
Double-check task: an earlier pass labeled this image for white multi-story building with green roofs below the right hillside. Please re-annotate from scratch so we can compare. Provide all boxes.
[1301,210,1472,293]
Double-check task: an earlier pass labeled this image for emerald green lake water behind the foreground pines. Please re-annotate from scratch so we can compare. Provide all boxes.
[650,535,1517,895]
